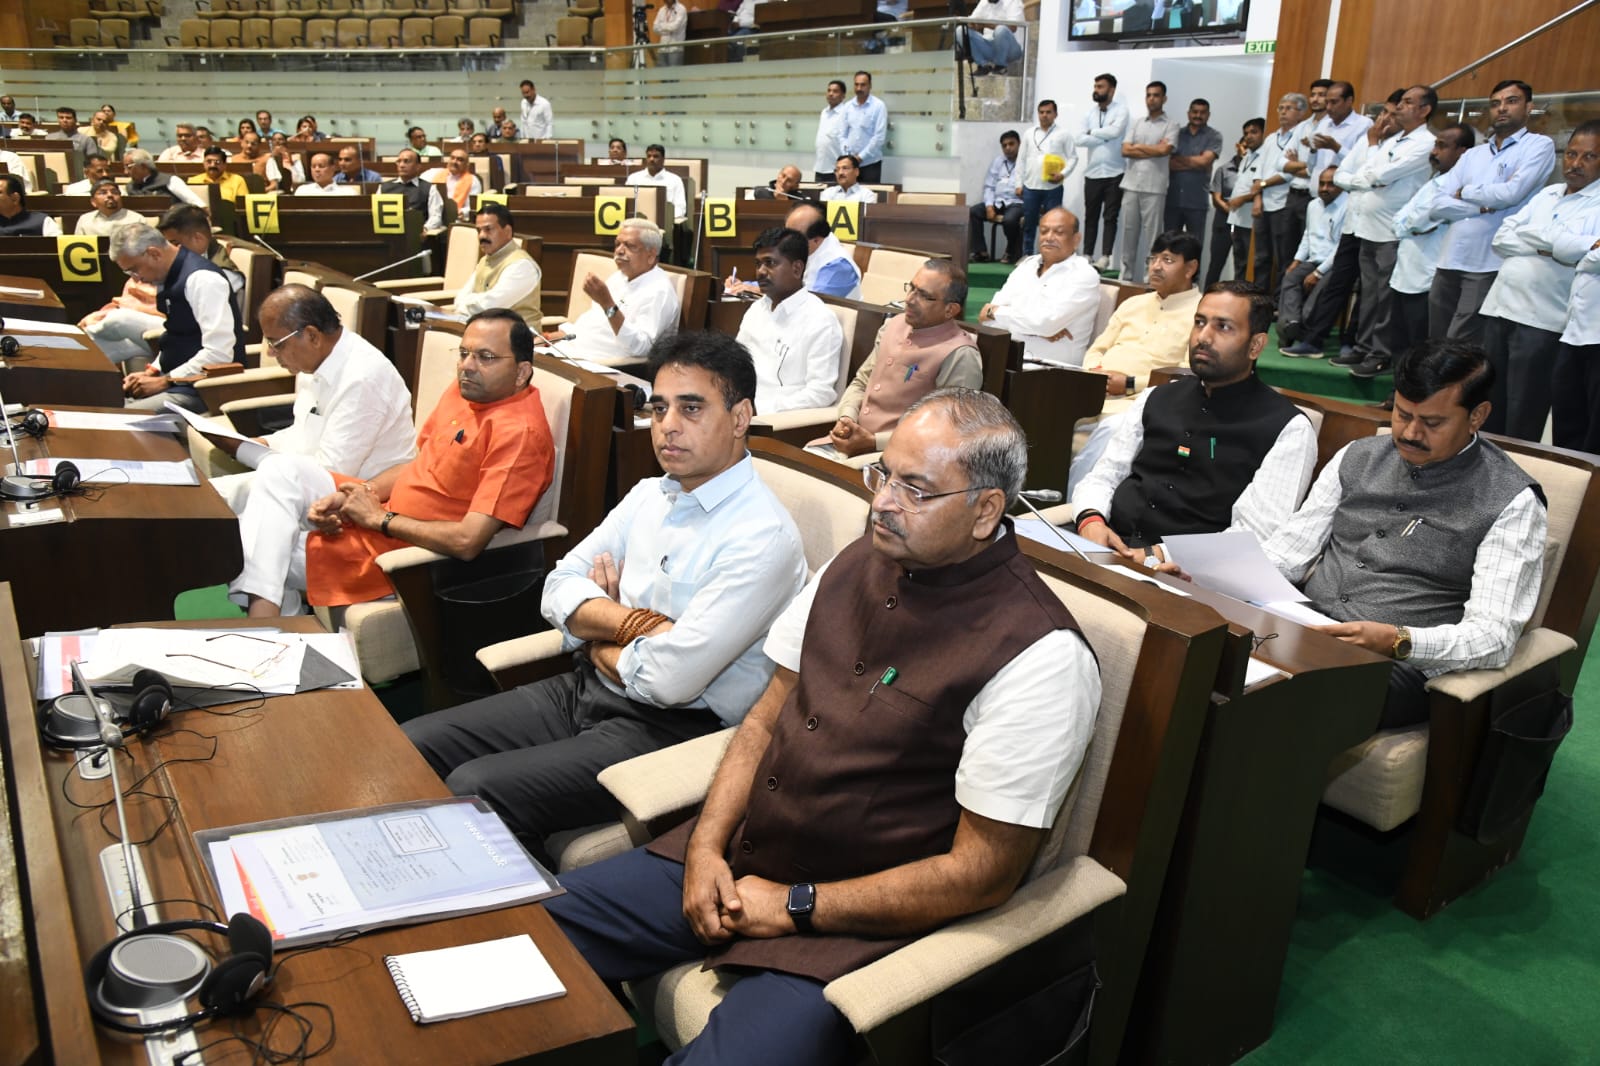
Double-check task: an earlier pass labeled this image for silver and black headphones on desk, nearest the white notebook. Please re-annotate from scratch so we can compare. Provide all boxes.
[83,912,272,1034]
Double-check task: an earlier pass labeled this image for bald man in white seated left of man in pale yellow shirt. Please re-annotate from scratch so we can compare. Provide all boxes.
[978,208,1099,367]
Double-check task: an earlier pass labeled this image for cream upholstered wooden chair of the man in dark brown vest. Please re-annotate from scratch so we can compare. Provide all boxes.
[600,544,1222,1063]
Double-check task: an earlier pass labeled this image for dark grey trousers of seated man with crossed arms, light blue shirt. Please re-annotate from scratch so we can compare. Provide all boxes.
[402,656,722,864]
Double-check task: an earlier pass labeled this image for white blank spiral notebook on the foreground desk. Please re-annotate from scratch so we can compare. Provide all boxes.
[384,933,566,1024]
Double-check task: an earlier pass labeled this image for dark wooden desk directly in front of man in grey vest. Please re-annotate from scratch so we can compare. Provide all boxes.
[1101,584,1392,1064]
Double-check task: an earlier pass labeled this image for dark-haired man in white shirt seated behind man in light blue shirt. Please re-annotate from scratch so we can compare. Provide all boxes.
[739,229,845,415]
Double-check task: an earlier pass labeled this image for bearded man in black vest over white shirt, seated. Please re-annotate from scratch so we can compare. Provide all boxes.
[1072,282,1317,567]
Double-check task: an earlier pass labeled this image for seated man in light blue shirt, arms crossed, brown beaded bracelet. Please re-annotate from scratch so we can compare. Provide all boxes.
[405,333,806,863]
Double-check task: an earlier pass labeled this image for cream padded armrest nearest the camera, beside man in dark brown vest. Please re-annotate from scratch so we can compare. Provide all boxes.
[825,845,1128,1032]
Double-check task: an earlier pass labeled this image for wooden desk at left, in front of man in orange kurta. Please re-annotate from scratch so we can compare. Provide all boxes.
[0,408,243,637]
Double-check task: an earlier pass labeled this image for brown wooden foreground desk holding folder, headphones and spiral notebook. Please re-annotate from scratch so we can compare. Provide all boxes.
[0,586,634,1066]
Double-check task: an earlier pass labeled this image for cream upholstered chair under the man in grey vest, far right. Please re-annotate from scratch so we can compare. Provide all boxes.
[1323,427,1600,917]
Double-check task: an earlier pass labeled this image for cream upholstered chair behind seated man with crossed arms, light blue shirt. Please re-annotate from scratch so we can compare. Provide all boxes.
[478,437,870,869]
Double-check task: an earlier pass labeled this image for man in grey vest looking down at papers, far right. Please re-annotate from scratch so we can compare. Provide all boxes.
[1262,339,1546,728]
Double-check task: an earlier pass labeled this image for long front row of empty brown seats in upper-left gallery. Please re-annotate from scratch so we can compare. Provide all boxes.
[166,14,501,50]
